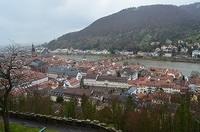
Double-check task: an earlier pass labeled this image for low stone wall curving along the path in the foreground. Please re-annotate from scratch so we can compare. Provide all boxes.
[9,111,122,132]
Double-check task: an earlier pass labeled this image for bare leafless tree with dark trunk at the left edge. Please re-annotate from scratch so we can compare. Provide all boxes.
[0,45,22,132]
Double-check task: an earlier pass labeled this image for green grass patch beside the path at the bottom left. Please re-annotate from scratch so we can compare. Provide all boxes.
[0,123,57,132]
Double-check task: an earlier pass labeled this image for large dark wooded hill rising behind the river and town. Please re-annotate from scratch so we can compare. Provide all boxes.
[47,3,200,50]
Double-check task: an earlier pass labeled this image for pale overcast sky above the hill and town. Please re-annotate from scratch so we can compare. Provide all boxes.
[0,0,199,46]
